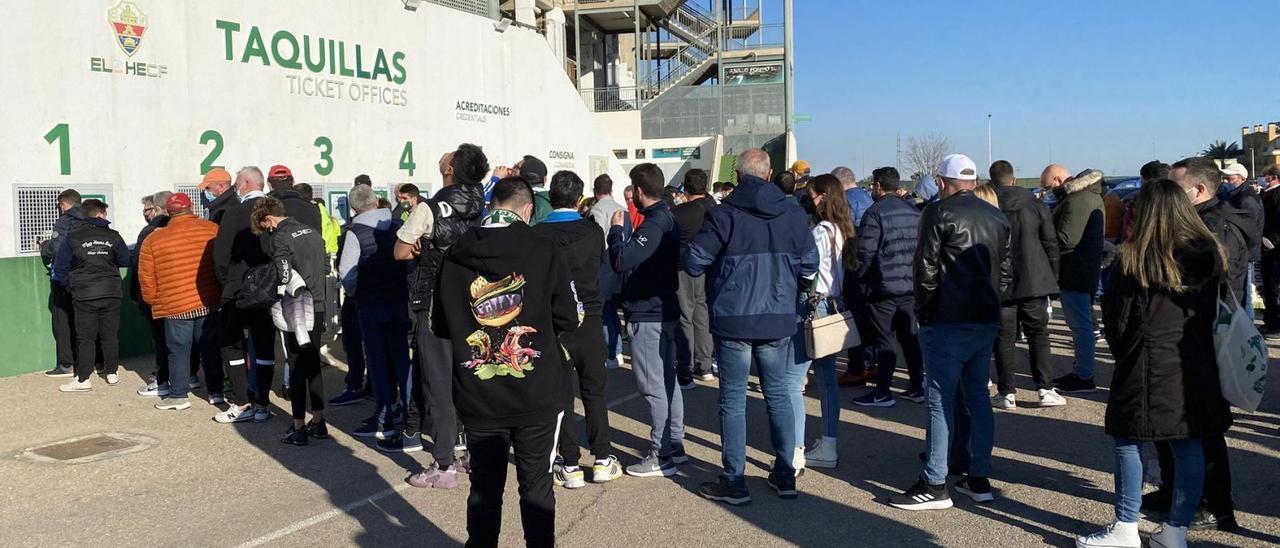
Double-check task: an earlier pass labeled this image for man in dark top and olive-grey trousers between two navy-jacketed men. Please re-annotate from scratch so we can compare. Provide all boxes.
[671,169,716,388]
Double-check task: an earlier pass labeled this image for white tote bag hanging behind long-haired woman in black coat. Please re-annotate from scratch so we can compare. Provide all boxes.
[1213,291,1267,411]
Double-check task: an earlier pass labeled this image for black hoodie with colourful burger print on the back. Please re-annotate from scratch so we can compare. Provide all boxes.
[431,222,579,429]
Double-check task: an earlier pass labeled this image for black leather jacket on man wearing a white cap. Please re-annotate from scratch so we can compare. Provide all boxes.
[915,191,1014,325]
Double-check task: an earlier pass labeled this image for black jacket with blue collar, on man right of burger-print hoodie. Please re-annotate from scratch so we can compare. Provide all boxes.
[534,209,604,316]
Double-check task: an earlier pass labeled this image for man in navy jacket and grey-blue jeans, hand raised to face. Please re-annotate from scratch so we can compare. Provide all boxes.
[608,163,689,478]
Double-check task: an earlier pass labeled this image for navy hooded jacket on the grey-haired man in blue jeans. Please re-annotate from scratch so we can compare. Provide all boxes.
[685,175,818,341]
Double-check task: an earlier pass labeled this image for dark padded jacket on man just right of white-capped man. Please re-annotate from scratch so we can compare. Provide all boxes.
[996,186,1059,302]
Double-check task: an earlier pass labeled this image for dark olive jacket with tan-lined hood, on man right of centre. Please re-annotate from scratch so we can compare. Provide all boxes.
[1053,169,1106,294]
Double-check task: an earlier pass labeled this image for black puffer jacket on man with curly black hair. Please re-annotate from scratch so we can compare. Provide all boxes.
[408,183,484,311]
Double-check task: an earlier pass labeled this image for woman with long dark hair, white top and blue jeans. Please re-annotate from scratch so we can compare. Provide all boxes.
[790,174,855,471]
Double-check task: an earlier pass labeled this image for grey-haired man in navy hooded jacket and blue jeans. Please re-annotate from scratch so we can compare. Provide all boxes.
[686,149,818,504]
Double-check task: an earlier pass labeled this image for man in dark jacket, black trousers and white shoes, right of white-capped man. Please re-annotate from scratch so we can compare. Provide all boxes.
[991,160,1066,410]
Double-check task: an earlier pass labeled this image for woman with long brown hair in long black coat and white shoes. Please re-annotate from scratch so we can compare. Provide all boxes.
[1075,179,1231,548]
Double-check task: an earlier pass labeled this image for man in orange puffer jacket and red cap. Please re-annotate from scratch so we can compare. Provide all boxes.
[138,192,223,410]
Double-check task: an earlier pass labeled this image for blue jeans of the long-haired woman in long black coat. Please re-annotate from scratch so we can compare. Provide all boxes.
[1115,438,1204,528]
